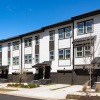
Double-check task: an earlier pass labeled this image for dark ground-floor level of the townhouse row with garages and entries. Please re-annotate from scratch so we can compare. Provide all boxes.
[0,62,100,85]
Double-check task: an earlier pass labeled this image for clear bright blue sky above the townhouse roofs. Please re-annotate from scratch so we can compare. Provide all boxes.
[0,0,100,39]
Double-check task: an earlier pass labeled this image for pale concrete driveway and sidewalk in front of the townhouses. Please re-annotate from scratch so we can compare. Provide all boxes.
[0,84,82,100]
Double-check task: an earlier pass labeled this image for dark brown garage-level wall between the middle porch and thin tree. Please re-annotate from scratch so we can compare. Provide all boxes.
[51,71,89,85]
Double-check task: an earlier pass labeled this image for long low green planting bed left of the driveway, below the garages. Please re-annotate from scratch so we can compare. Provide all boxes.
[7,83,39,88]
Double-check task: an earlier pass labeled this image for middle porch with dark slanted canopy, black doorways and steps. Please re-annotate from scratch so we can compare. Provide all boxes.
[31,61,52,84]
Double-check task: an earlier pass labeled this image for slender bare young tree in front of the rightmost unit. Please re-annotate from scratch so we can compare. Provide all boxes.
[83,34,100,95]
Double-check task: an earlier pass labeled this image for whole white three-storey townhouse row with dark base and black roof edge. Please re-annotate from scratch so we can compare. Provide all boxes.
[0,10,100,84]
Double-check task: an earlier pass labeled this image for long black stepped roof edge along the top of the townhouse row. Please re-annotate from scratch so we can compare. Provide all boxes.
[0,9,100,43]
